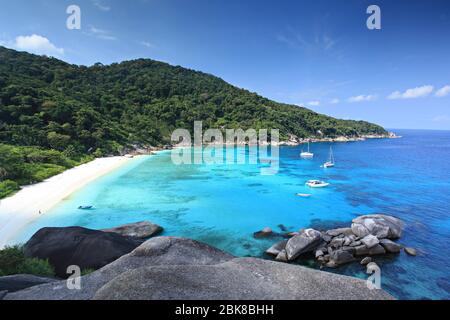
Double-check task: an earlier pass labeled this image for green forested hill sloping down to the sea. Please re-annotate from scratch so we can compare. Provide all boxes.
[0,47,385,198]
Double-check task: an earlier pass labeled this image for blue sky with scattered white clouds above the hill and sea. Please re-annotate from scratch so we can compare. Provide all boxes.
[0,0,450,129]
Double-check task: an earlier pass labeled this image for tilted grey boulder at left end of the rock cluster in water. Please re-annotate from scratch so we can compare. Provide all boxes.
[286,229,322,261]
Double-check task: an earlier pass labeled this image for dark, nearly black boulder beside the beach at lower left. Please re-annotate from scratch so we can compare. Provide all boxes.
[25,227,142,278]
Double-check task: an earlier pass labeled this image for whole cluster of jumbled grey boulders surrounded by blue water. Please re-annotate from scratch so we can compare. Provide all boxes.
[266,214,415,268]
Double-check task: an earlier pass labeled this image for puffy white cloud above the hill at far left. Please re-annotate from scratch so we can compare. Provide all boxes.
[9,34,64,56]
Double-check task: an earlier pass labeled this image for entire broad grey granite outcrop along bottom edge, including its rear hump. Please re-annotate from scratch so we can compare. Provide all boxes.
[5,237,392,300]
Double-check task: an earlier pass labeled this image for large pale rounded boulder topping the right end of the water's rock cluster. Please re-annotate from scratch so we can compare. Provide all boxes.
[352,214,404,239]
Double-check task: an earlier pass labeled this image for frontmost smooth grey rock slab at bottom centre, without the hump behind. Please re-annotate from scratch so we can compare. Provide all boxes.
[94,258,391,300]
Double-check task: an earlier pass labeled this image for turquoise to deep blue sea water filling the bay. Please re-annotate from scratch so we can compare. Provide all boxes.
[12,130,450,299]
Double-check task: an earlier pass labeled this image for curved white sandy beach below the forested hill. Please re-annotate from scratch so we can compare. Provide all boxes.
[0,157,137,248]
